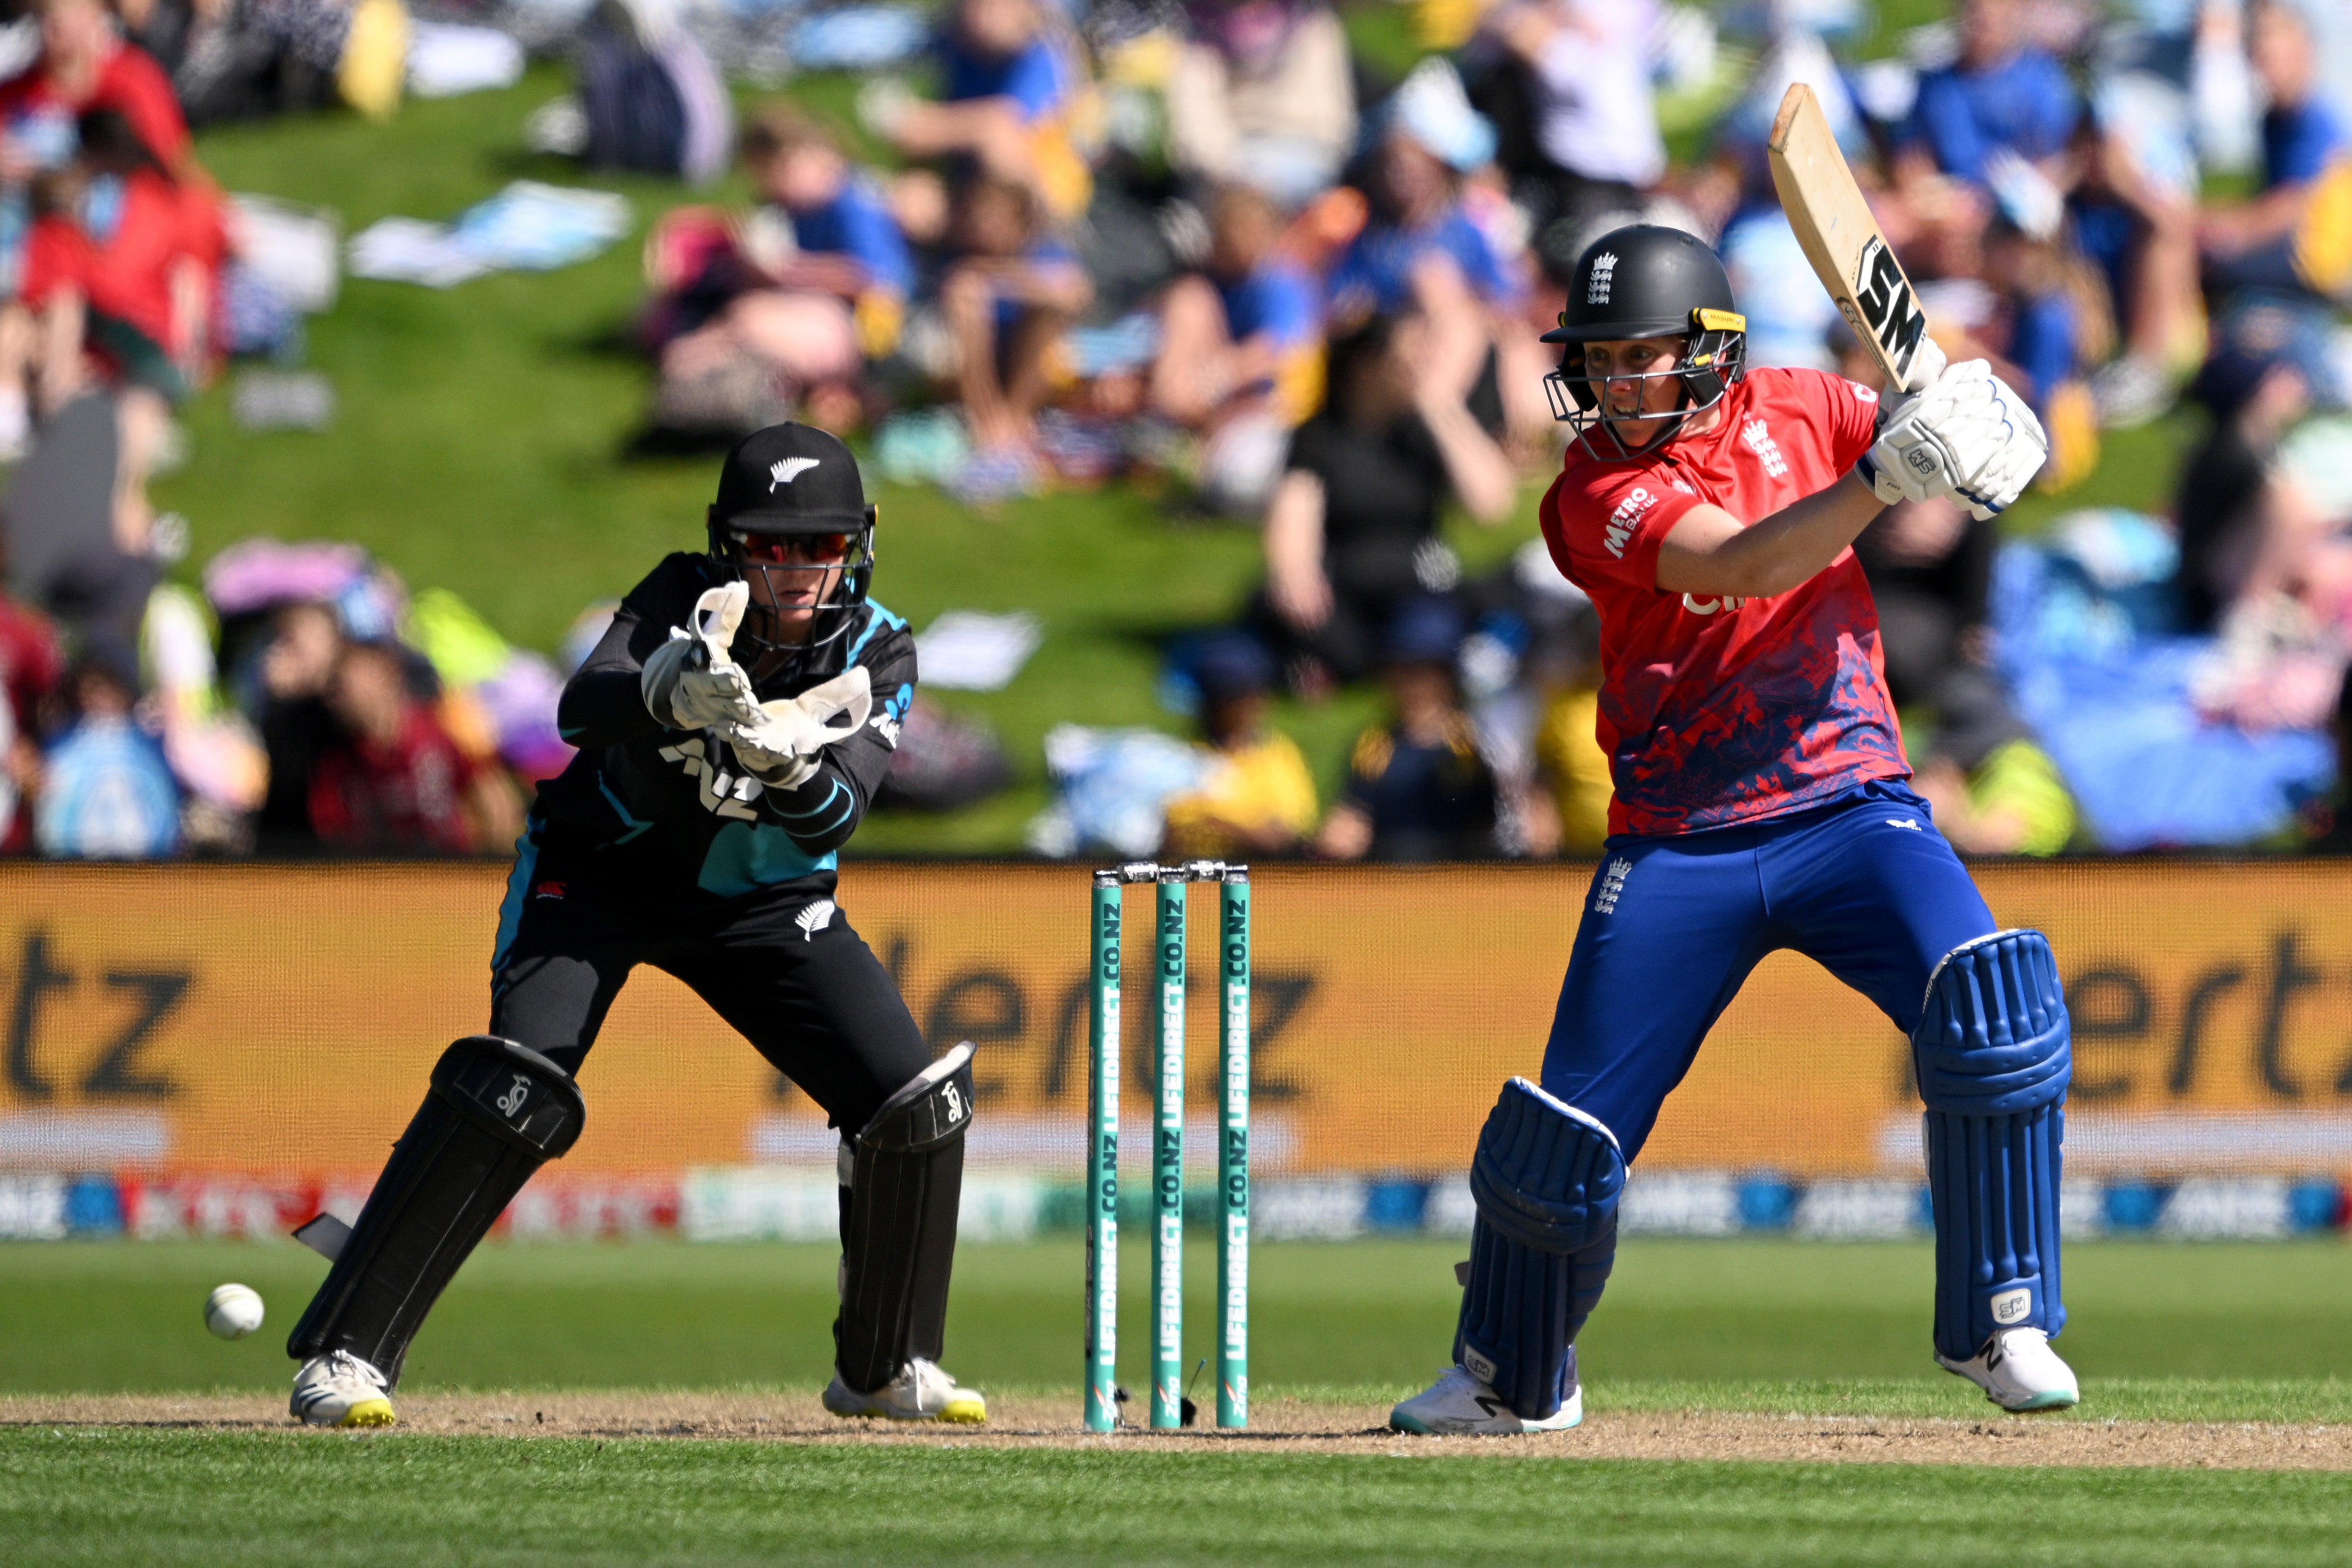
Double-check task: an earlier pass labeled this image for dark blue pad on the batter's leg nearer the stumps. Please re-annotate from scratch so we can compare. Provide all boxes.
[1454,1079,1625,1420]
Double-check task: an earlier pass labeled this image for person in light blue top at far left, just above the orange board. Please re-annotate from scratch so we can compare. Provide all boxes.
[33,661,179,861]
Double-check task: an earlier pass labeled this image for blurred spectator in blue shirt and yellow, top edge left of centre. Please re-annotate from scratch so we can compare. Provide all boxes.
[859,0,1094,219]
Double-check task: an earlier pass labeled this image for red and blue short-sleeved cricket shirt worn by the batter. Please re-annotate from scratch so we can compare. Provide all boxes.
[1541,369,1910,834]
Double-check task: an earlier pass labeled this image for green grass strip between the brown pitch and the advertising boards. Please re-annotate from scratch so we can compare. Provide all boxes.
[14,1239,2352,1422]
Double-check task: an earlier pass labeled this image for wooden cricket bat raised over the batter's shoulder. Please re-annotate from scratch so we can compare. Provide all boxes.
[1764,82,1927,393]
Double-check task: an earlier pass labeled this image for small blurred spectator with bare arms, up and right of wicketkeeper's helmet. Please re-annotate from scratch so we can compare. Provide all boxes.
[938,179,1094,466]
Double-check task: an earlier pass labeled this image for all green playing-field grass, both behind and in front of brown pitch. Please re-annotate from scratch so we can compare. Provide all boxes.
[0,1241,2352,1568]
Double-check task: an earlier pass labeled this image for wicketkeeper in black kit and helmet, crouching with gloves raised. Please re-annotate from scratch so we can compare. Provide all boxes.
[287,425,988,1427]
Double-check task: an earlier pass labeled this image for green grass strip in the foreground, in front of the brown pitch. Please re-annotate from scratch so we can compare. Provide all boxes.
[18,1427,2352,1568]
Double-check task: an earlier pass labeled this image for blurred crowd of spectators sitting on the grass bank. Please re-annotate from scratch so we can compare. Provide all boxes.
[0,0,2352,858]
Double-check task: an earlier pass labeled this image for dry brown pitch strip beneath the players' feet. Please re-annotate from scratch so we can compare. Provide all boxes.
[18,1392,2352,1469]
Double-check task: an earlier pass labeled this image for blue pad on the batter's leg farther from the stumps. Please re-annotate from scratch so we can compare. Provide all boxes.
[1912,931,2072,1361]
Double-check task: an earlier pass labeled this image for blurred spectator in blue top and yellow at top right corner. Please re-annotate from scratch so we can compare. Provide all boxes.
[2197,0,2352,301]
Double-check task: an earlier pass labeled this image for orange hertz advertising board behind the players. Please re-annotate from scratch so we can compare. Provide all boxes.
[0,863,2352,1180]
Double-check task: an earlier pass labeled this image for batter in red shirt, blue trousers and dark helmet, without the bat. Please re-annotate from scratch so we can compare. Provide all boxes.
[1390,226,2077,1432]
